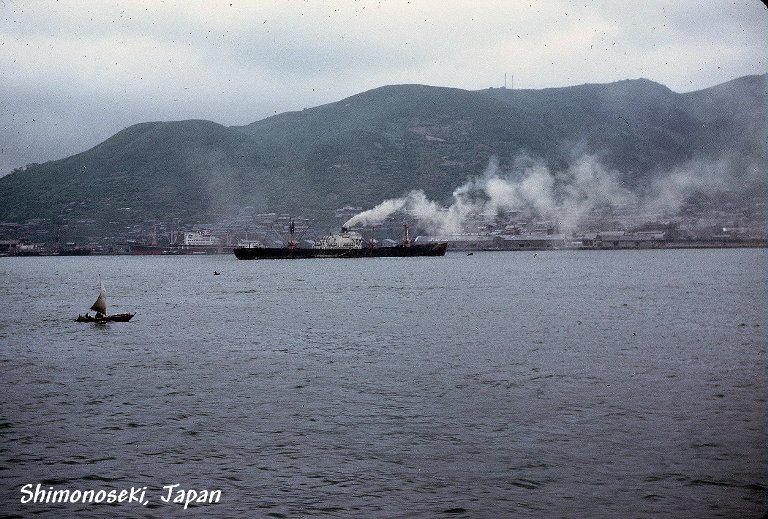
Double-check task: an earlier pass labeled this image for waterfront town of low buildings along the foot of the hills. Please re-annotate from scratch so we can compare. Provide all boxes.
[0,198,768,256]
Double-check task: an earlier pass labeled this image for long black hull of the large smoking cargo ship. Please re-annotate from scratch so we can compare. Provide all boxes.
[234,243,448,260]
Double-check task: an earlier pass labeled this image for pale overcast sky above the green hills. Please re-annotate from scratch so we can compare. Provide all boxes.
[0,0,768,174]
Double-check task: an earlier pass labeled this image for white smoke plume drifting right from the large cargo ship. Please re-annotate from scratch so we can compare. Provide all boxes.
[344,155,759,234]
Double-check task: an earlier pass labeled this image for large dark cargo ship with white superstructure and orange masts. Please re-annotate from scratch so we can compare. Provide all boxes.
[234,222,448,260]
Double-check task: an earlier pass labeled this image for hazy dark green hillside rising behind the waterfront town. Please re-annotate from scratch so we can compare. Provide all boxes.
[0,75,766,235]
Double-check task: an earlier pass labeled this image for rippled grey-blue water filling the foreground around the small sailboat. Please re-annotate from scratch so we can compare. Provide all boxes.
[0,249,768,518]
